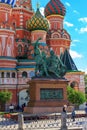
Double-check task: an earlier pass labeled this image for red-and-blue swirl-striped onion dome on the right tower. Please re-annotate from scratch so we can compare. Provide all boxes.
[44,0,66,17]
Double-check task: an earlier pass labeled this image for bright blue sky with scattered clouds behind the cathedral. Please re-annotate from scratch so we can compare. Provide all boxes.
[32,0,87,73]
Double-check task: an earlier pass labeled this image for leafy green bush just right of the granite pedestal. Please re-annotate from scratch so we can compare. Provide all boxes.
[67,86,86,105]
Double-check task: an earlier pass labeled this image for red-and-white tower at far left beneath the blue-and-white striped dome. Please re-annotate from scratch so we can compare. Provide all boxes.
[0,0,16,68]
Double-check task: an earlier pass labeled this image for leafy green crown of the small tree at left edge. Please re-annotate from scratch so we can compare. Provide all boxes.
[0,91,12,103]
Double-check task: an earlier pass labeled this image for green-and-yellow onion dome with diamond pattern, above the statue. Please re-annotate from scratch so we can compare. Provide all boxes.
[27,8,49,31]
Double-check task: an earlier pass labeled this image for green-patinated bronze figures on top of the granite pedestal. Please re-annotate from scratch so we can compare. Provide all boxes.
[34,38,66,78]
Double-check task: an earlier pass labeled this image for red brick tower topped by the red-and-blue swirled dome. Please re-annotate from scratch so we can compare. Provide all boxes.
[45,0,71,55]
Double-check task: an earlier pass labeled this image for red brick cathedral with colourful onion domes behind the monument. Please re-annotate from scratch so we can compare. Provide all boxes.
[0,0,85,106]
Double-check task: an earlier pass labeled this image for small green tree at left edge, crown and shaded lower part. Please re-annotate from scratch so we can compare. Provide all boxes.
[0,90,12,111]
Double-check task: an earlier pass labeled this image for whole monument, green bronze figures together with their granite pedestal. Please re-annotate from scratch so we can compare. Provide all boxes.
[25,39,68,114]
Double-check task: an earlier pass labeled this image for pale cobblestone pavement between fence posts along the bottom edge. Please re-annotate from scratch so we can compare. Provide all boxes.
[0,110,87,130]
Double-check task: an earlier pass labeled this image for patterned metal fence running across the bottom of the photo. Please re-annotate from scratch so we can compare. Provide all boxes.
[0,114,87,130]
